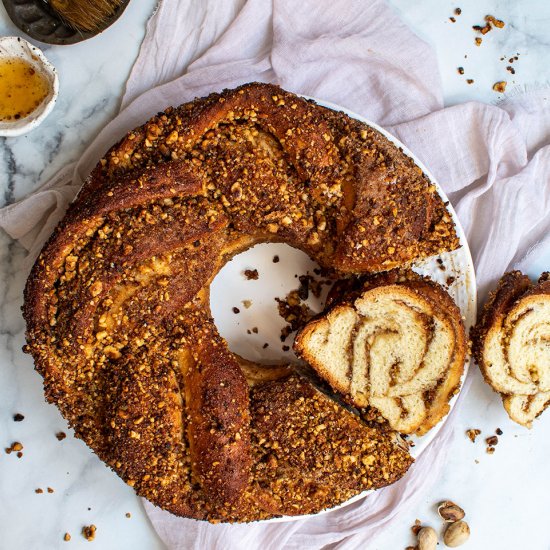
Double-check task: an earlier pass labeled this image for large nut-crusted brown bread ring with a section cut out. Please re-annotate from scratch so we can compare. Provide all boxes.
[24,83,459,522]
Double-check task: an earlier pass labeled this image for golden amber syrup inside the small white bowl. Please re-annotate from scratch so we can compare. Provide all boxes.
[0,57,50,121]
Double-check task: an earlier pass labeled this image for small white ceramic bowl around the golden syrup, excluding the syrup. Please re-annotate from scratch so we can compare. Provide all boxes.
[0,36,59,137]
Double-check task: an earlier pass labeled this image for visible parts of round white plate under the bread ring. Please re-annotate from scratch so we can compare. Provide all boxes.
[211,98,476,522]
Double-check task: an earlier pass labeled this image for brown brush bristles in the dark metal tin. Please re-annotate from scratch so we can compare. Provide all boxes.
[49,0,123,32]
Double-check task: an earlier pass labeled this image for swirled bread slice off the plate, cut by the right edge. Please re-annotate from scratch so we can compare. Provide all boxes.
[471,271,550,428]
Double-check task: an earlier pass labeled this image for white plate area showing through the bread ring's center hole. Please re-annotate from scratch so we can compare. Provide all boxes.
[210,243,330,364]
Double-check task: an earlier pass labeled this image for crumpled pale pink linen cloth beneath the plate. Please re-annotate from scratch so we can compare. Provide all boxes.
[0,0,550,550]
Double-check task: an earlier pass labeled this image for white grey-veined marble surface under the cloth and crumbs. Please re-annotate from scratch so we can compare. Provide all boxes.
[0,0,550,550]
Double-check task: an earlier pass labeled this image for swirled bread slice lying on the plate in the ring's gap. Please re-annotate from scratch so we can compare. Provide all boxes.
[294,271,466,435]
